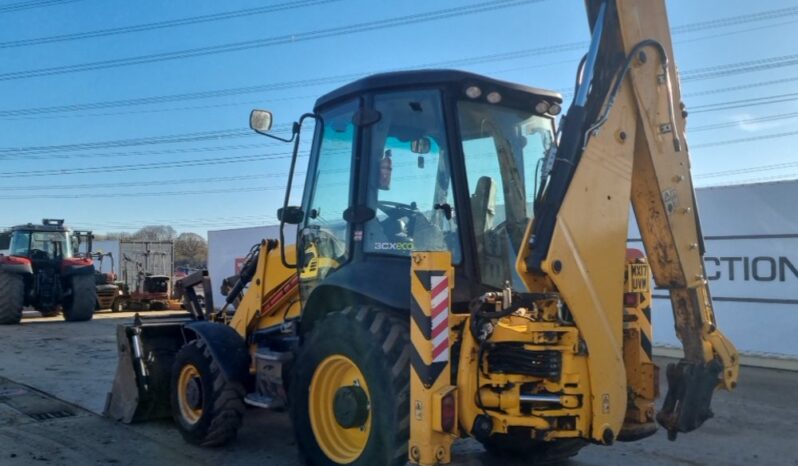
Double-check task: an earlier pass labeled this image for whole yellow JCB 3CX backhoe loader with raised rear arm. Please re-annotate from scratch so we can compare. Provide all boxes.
[106,0,738,465]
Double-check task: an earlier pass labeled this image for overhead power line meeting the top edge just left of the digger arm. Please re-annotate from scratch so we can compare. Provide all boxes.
[0,0,547,81]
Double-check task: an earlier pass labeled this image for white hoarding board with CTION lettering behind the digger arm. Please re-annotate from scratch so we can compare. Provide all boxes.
[630,181,798,358]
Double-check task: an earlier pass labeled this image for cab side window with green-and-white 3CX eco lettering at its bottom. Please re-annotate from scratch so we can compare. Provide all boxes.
[363,91,461,264]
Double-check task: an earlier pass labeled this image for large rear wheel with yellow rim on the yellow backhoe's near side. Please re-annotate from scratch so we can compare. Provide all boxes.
[289,306,410,466]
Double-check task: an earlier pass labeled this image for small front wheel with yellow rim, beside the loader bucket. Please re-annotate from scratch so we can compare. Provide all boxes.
[171,340,245,447]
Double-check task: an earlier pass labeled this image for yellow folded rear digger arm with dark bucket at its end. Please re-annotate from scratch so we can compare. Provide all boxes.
[517,0,739,440]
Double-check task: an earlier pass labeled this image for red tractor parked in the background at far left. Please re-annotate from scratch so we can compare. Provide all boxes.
[0,219,97,325]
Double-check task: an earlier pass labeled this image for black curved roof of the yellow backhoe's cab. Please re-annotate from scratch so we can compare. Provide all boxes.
[315,70,562,111]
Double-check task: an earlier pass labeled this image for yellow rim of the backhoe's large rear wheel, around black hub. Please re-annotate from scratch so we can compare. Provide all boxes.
[308,354,371,464]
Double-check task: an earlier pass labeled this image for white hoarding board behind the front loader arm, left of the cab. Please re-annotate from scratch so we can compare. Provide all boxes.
[208,225,296,307]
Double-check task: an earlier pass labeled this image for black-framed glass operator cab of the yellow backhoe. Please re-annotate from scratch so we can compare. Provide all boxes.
[253,70,562,307]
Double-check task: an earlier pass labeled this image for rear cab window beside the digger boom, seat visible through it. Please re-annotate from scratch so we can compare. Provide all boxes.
[458,101,554,288]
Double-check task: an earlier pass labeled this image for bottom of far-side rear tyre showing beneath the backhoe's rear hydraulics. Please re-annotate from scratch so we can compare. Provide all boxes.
[482,429,587,464]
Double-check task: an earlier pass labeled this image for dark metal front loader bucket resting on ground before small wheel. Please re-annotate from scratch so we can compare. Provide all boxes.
[103,315,191,423]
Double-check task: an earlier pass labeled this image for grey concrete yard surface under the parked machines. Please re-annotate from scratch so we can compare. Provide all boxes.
[0,312,798,466]
